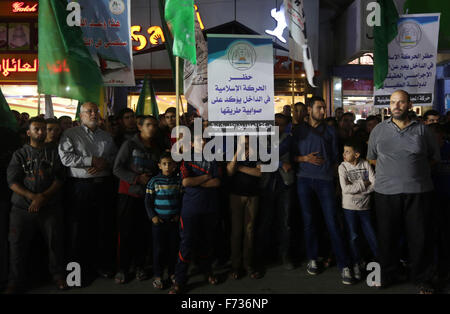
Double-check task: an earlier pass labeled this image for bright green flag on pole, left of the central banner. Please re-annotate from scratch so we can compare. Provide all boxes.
[164,0,197,64]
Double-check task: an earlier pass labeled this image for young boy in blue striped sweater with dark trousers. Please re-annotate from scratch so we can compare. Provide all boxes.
[145,152,181,290]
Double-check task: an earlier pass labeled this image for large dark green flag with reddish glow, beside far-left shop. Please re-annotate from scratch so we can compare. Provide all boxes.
[38,0,103,104]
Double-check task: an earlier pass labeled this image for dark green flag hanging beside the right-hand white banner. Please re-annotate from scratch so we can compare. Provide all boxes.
[373,0,398,89]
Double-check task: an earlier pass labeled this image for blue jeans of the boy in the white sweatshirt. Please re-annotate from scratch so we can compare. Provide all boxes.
[344,209,378,265]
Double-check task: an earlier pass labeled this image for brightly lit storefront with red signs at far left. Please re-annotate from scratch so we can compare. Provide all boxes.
[0,0,77,117]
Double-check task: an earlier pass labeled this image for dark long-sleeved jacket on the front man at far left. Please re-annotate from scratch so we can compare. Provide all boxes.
[7,144,65,210]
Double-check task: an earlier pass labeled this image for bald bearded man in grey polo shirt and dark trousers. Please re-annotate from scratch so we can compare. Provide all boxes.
[367,90,440,294]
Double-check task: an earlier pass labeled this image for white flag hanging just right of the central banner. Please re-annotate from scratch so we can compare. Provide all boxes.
[284,0,316,87]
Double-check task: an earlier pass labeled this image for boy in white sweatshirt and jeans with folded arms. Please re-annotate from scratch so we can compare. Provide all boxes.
[338,139,377,280]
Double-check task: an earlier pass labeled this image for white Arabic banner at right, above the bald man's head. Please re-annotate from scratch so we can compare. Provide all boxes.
[374,13,440,107]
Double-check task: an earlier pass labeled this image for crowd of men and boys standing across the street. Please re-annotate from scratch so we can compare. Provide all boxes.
[0,90,450,294]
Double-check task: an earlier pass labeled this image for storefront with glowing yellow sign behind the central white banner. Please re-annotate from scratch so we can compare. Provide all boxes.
[127,0,319,113]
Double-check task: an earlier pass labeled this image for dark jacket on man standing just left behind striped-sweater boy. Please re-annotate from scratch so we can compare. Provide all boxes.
[113,134,162,197]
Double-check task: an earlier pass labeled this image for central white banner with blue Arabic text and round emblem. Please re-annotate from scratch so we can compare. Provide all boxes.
[208,34,275,135]
